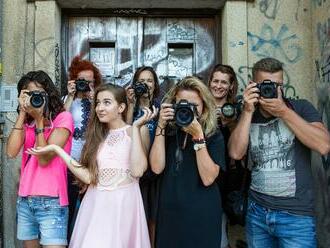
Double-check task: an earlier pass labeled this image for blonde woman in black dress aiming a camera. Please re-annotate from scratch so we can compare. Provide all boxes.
[149,76,225,248]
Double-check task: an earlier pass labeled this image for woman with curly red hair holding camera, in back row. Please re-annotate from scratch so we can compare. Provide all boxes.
[63,56,102,240]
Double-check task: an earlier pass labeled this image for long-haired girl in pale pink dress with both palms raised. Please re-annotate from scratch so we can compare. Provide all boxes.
[29,84,157,248]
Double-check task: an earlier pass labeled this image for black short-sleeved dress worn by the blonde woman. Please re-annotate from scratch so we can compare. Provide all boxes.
[156,131,225,248]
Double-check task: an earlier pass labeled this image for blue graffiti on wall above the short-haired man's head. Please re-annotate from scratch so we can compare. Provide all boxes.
[247,24,303,63]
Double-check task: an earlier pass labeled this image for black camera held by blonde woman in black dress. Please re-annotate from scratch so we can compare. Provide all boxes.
[173,99,197,127]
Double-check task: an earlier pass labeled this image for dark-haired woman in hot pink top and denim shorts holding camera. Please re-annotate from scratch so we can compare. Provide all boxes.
[7,71,73,248]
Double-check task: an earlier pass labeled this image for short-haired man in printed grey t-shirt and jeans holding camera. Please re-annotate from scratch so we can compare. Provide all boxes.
[228,58,330,248]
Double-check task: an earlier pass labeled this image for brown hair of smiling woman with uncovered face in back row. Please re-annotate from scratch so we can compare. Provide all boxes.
[208,64,238,103]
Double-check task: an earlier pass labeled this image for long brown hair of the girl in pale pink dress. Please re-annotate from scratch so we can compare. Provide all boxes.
[80,84,127,185]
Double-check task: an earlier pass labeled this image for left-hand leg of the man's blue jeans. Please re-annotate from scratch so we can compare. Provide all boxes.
[245,201,277,248]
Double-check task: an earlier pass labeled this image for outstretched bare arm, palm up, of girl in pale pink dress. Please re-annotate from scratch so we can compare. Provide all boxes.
[28,144,91,184]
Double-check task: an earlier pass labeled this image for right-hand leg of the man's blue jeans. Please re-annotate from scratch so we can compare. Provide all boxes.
[275,211,317,248]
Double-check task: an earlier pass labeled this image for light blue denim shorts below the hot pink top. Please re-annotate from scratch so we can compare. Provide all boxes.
[16,196,68,245]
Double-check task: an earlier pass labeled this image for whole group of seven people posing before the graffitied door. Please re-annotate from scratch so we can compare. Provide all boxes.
[7,57,330,248]
